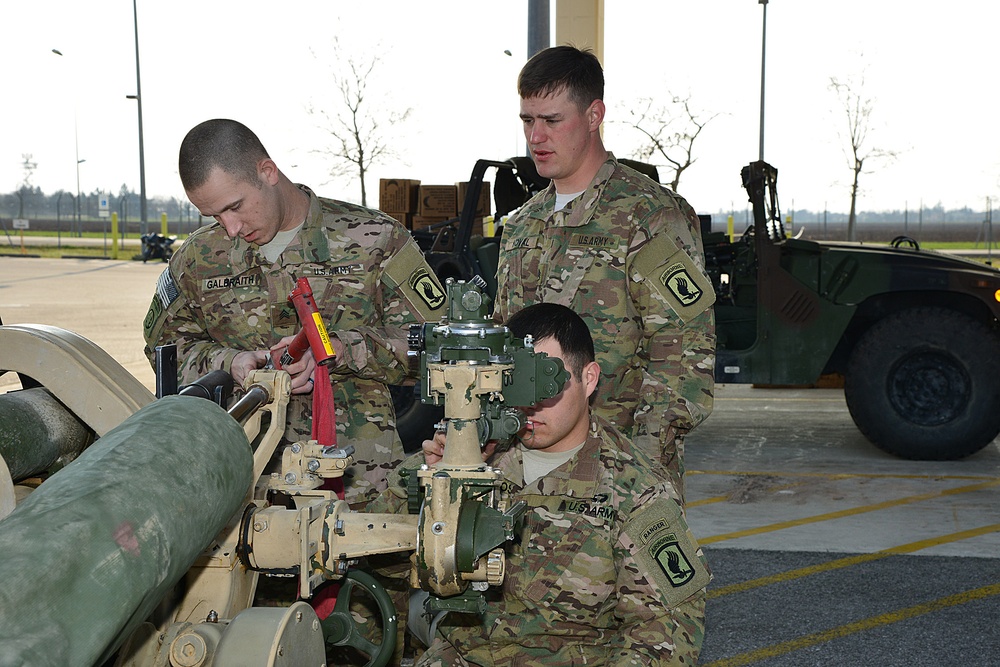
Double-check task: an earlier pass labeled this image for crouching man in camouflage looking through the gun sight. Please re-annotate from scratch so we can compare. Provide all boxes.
[369,304,711,667]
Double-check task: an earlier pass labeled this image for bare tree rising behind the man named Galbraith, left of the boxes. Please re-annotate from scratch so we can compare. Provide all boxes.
[309,39,413,206]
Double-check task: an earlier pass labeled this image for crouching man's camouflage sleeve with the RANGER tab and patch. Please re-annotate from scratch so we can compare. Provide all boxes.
[607,485,712,665]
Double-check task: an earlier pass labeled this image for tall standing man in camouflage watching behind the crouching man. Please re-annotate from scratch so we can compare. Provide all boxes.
[495,46,715,496]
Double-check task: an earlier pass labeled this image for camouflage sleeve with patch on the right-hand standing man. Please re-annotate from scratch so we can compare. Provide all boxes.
[630,205,715,468]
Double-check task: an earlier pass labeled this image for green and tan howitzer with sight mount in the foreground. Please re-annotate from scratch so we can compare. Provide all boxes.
[0,283,565,667]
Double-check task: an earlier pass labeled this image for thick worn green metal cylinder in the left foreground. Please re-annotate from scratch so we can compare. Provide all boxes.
[0,396,253,666]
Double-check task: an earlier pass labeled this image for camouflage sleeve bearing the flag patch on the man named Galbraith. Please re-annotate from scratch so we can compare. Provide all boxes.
[143,264,239,384]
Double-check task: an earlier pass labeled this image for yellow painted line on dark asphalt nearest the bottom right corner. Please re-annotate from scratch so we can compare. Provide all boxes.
[702,584,1000,667]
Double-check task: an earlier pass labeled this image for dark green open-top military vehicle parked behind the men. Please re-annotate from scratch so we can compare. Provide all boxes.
[397,158,1000,460]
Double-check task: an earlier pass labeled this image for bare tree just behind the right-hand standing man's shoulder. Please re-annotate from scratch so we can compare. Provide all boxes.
[620,95,719,192]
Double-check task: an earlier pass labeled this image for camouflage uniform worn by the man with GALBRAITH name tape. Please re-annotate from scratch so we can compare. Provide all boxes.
[143,188,446,501]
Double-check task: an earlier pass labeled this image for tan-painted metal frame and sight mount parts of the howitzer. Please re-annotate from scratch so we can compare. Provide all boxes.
[0,325,509,667]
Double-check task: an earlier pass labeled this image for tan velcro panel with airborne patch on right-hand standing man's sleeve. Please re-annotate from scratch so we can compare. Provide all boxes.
[632,234,715,322]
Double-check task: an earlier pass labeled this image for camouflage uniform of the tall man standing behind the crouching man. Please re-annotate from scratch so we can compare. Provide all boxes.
[494,154,715,488]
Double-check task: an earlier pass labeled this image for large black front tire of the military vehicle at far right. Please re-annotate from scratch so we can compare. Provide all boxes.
[844,308,1000,461]
